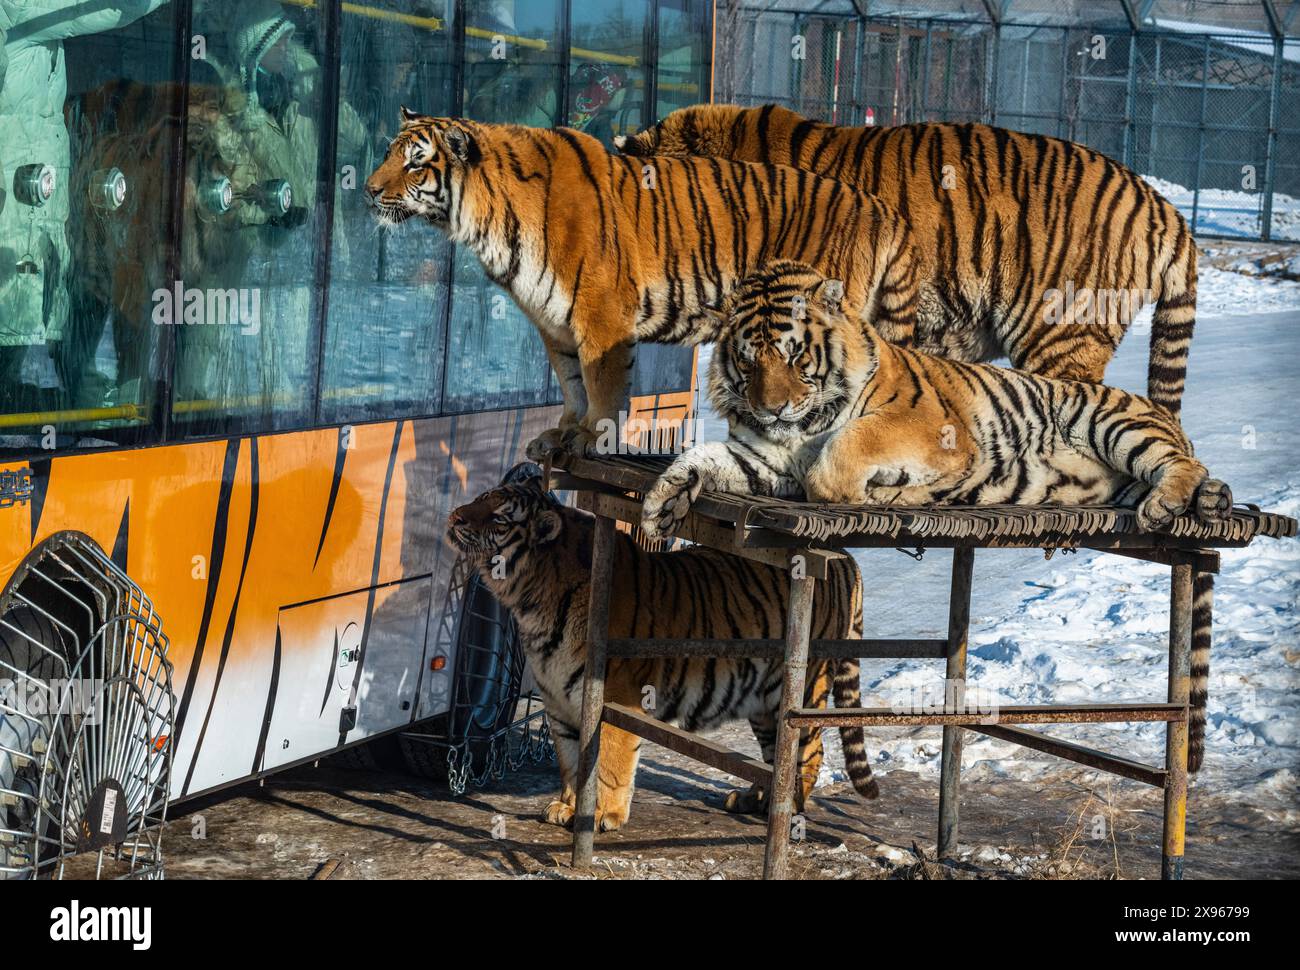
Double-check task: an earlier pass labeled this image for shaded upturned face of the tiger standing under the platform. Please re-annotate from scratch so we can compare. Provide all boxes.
[447,477,564,581]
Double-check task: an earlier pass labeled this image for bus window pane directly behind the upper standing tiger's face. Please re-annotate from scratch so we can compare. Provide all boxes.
[320,0,455,423]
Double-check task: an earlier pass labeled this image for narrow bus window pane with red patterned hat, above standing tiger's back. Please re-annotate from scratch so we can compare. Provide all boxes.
[568,0,650,150]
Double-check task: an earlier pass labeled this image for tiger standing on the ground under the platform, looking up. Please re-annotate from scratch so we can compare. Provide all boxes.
[447,477,878,831]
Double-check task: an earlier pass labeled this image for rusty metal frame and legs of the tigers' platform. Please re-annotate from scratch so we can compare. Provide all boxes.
[555,458,1295,879]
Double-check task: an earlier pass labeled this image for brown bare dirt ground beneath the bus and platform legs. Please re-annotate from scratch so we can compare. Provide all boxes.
[164,727,1300,879]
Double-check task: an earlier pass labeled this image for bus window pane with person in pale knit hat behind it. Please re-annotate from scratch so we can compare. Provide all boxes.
[170,0,335,434]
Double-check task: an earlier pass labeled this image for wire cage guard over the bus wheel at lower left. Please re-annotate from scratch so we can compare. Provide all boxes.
[0,533,174,879]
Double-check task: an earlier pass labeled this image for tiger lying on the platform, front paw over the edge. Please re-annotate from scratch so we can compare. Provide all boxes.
[642,261,1232,771]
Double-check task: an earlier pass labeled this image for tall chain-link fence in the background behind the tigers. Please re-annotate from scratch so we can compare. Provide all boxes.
[714,0,1300,239]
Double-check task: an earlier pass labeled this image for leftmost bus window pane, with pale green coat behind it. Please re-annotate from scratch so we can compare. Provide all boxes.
[0,0,182,452]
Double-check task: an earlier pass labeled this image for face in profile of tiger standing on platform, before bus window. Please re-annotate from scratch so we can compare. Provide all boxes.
[365,107,482,226]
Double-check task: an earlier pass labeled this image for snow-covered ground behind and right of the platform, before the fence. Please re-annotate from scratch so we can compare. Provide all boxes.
[699,257,1300,818]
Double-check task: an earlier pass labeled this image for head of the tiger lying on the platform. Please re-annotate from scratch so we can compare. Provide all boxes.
[710,261,846,437]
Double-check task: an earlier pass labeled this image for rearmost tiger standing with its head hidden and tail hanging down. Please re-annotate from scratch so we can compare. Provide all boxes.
[615,104,1197,416]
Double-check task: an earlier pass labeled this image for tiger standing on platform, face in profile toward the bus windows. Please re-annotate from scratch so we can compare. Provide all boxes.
[365,108,918,455]
